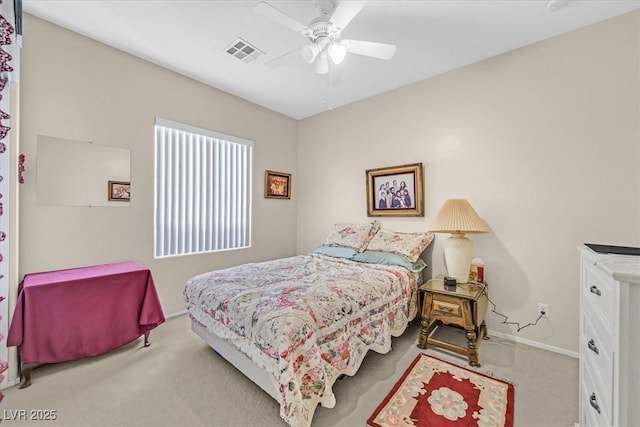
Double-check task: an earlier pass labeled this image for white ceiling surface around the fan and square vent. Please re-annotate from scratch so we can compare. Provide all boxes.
[23,0,640,119]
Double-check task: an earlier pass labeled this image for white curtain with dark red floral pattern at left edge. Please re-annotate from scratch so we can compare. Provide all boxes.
[0,0,20,401]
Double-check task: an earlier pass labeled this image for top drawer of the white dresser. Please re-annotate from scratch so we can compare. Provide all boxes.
[581,263,617,334]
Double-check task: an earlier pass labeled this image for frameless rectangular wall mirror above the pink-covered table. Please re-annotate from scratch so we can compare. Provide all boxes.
[36,135,131,206]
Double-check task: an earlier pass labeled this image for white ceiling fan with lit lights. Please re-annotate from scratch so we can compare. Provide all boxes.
[253,0,396,74]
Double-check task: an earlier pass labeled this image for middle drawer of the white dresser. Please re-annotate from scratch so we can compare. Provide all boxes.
[580,311,614,402]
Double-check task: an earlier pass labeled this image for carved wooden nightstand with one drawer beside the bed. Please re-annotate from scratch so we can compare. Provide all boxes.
[418,277,488,366]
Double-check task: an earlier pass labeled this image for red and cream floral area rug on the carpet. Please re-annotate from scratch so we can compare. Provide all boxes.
[367,354,514,427]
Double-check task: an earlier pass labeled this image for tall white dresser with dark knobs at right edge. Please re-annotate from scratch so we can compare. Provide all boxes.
[578,246,640,427]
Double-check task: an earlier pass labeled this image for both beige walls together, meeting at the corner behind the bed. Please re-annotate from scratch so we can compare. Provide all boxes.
[20,9,640,362]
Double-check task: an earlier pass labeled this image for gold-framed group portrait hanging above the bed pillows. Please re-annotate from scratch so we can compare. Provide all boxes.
[367,163,424,216]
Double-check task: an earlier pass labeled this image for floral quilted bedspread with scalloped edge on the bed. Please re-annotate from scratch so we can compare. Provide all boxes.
[184,253,417,427]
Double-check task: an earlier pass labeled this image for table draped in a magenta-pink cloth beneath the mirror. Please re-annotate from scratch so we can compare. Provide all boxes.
[7,261,165,388]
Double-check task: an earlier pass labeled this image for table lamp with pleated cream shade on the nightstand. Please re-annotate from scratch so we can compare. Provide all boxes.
[429,199,489,283]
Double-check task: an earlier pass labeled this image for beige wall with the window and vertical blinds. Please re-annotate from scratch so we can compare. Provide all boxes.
[19,15,297,314]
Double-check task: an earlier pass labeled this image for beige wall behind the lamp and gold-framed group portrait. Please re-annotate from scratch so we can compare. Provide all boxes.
[298,13,640,353]
